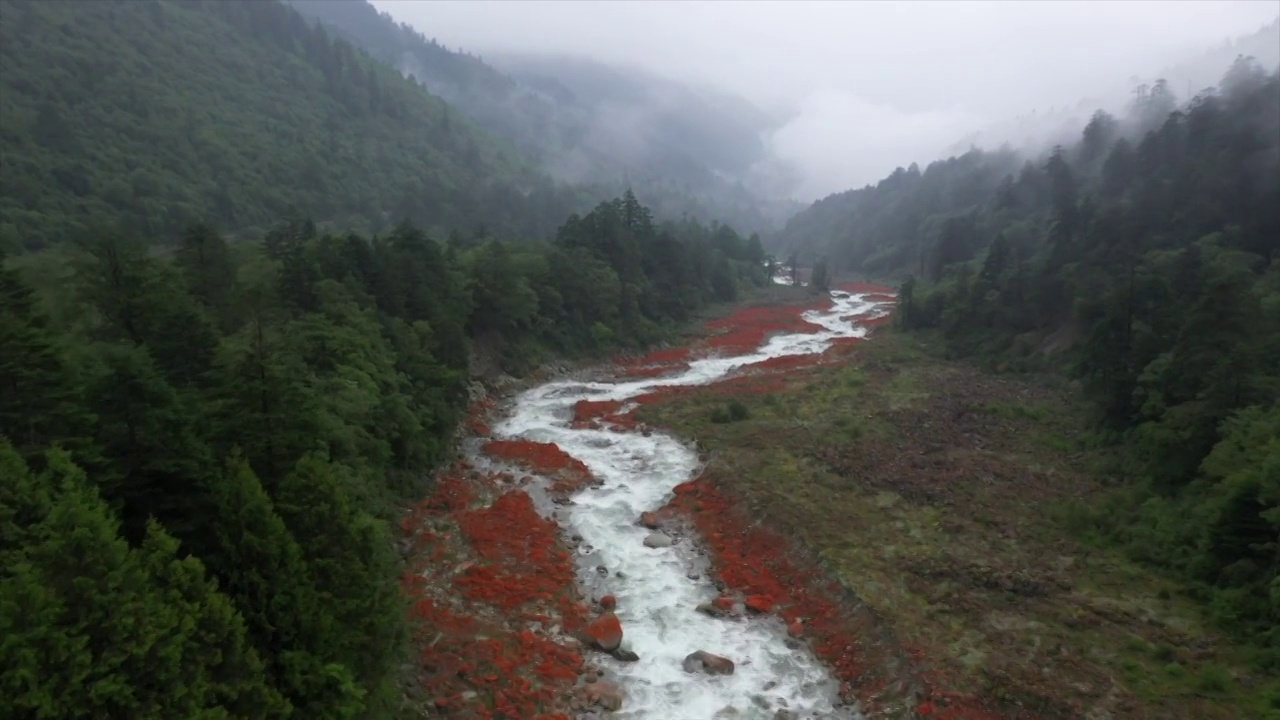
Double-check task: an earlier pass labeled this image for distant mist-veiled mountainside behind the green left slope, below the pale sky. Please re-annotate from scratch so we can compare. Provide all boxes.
[289,0,797,232]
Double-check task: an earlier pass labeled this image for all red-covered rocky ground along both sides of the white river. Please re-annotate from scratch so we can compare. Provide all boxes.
[403,284,1018,720]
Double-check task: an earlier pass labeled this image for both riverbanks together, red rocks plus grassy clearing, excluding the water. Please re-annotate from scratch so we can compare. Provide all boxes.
[406,286,1248,720]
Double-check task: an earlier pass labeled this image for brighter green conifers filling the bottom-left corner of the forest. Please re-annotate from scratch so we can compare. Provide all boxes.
[0,442,289,719]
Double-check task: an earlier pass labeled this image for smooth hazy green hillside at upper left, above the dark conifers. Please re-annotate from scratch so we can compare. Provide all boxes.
[0,0,579,249]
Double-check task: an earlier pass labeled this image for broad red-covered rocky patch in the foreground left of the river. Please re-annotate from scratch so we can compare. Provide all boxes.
[402,464,586,720]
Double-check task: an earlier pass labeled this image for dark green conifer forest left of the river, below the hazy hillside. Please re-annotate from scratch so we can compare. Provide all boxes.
[0,193,767,717]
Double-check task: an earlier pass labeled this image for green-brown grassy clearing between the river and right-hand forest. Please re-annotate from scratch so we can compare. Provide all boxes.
[639,329,1265,720]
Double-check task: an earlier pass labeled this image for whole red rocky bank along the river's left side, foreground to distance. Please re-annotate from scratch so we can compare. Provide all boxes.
[402,283,880,720]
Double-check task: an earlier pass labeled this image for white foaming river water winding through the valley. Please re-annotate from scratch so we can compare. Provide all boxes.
[494,291,888,720]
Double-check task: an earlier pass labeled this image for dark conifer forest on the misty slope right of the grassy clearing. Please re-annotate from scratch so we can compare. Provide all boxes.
[788,58,1280,671]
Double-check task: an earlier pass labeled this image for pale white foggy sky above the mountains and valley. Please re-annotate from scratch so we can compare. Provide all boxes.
[374,0,1280,200]
